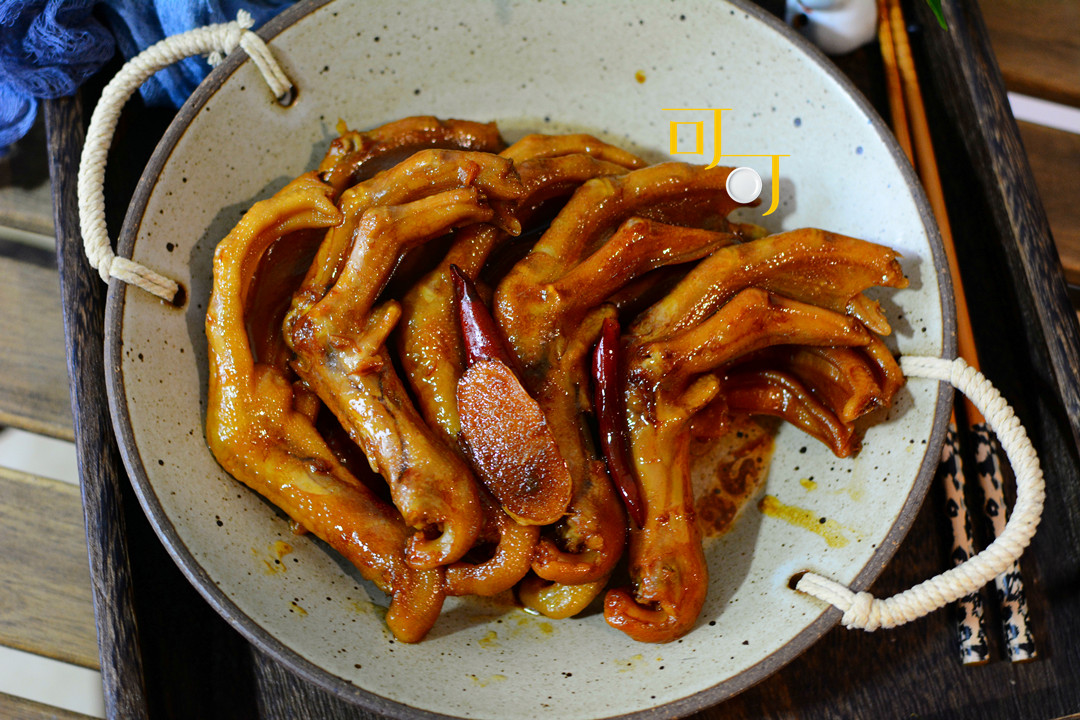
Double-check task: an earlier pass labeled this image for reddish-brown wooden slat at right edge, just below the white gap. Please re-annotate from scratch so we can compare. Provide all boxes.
[1017,118,1080,285]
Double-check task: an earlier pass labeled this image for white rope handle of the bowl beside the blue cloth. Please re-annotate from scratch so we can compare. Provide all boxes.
[79,10,293,302]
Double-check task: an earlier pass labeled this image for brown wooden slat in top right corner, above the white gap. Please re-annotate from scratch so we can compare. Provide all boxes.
[980,0,1080,107]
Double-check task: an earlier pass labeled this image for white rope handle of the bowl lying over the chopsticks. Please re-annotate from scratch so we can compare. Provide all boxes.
[795,355,1047,631]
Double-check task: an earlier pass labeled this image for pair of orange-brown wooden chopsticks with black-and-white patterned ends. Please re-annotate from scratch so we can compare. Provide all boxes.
[878,0,1036,663]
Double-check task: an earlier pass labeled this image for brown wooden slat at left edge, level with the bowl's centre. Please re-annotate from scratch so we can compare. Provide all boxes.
[0,241,75,440]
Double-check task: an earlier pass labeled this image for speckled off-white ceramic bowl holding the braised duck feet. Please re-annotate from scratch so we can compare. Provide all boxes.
[107,0,953,720]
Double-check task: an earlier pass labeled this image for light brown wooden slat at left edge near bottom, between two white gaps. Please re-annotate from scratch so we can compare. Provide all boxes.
[0,467,98,669]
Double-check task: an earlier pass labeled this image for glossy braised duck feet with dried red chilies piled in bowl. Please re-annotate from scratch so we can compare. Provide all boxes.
[206,118,906,642]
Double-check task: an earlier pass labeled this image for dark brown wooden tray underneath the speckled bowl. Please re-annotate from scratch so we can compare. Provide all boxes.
[46,0,1080,720]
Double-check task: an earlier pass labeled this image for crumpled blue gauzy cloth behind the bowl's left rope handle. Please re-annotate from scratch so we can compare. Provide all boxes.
[0,0,294,155]
